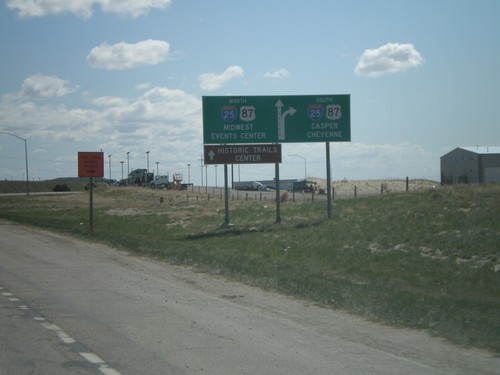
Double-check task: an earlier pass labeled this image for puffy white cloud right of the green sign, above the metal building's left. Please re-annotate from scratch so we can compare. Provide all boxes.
[354,43,424,77]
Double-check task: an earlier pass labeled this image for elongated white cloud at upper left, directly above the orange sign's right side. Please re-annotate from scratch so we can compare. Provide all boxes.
[87,39,170,70]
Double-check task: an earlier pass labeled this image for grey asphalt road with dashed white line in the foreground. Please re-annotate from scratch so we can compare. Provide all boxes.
[0,221,500,375]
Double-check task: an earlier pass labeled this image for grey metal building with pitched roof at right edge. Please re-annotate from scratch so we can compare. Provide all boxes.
[441,146,500,185]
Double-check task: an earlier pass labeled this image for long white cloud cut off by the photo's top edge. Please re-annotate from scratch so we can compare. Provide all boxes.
[7,0,172,19]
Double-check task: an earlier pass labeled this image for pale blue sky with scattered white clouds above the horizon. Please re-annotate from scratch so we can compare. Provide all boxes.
[0,0,500,186]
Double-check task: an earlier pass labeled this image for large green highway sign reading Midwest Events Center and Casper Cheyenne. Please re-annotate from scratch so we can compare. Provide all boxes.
[203,95,351,144]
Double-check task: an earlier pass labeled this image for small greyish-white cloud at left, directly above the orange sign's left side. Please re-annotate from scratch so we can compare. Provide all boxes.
[22,74,78,99]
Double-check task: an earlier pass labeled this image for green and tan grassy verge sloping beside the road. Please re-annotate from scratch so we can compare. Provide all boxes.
[0,185,500,353]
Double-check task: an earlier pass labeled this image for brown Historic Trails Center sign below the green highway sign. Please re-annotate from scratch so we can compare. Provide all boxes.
[204,143,281,164]
